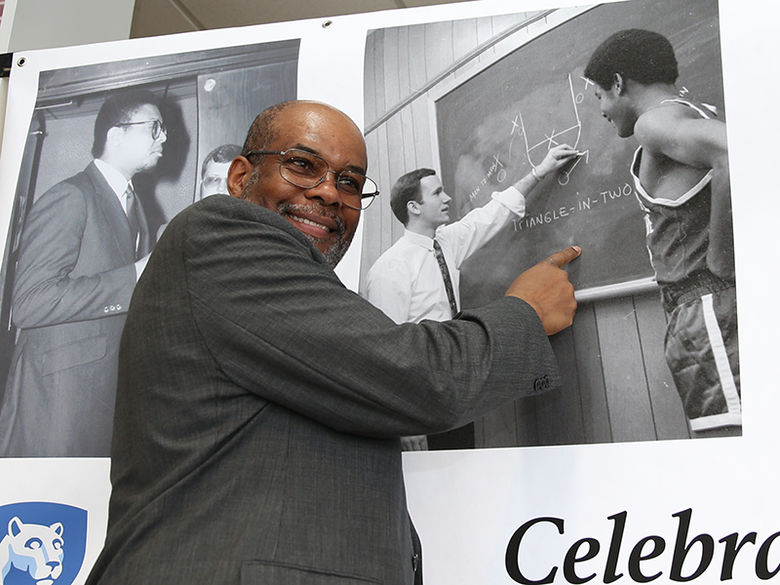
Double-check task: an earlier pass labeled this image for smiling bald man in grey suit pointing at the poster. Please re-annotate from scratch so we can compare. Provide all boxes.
[87,102,579,585]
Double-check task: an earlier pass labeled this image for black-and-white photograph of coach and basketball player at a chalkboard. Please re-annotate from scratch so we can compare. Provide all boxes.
[360,0,742,449]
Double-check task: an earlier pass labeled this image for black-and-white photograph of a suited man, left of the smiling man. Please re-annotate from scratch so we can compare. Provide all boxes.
[0,39,300,457]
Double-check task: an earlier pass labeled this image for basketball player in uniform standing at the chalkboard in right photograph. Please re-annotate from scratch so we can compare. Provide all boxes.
[584,29,741,436]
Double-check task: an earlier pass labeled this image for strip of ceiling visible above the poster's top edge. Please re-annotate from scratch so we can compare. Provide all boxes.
[130,0,466,38]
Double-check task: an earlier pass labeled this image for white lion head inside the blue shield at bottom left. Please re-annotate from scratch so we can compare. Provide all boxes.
[0,516,65,585]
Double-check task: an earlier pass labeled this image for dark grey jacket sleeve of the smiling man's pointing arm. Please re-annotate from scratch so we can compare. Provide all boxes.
[183,200,558,437]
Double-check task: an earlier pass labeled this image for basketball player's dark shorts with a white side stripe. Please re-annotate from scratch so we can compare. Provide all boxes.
[664,274,742,431]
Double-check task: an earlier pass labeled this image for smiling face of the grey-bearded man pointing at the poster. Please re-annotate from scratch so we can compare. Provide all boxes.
[231,102,367,266]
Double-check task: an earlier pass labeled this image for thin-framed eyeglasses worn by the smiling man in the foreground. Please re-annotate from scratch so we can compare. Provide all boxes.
[244,148,379,210]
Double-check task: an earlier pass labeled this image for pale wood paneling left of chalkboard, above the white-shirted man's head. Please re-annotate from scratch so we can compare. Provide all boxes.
[360,13,536,282]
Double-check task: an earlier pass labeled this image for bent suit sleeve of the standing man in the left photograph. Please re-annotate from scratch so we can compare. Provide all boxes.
[13,173,136,328]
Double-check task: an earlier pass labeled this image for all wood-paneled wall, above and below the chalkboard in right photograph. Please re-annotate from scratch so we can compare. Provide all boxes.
[361,13,690,447]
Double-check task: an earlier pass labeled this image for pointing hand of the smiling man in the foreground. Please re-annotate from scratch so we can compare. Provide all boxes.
[506,246,582,335]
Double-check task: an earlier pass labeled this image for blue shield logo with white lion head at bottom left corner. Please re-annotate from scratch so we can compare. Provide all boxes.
[0,502,87,585]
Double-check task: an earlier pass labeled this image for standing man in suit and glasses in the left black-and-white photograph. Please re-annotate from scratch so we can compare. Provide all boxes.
[0,91,167,457]
